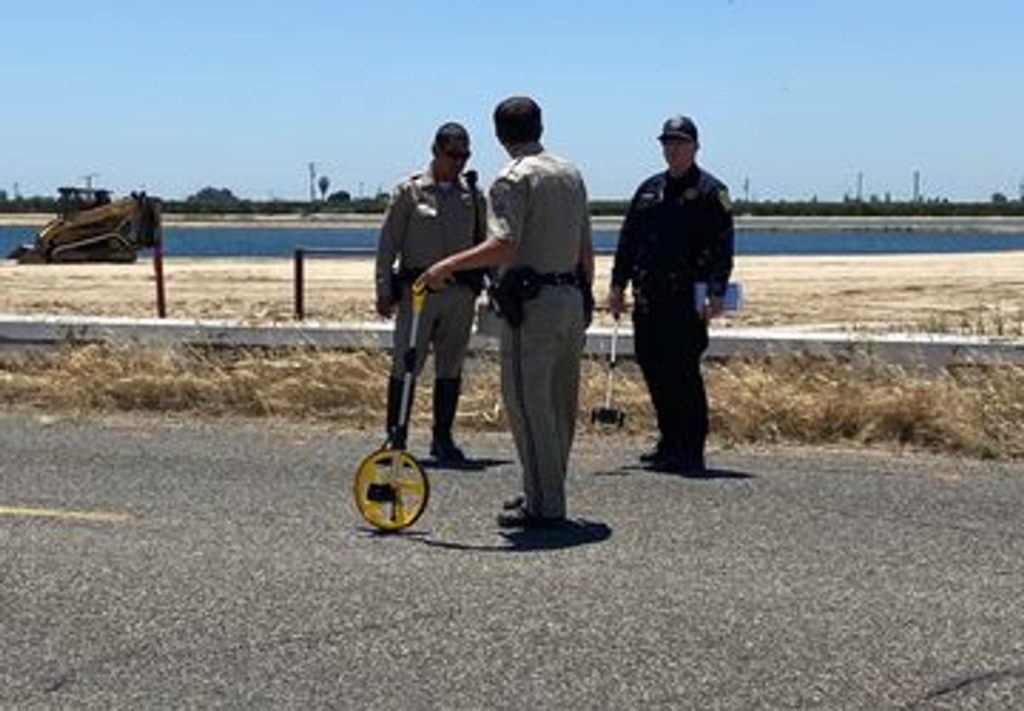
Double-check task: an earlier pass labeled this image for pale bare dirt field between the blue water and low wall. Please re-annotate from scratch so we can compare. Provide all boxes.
[0,252,1024,336]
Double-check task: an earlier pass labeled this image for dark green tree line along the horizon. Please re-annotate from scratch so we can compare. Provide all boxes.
[0,186,1024,217]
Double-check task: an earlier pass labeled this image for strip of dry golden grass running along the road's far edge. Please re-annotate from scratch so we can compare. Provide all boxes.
[0,345,1024,458]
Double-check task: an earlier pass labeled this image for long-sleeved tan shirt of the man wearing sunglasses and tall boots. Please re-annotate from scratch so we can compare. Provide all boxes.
[375,167,475,297]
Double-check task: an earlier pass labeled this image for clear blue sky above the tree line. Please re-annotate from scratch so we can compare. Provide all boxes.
[0,0,1024,200]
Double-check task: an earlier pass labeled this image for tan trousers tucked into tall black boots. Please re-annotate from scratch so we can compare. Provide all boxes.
[391,285,476,380]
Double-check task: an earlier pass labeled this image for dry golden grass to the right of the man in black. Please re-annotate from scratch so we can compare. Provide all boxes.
[709,356,1024,457]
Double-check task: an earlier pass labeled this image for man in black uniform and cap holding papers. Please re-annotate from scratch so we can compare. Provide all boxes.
[608,116,733,473]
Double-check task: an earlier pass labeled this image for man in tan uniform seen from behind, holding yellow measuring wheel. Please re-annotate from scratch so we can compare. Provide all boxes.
[425,96,594,528]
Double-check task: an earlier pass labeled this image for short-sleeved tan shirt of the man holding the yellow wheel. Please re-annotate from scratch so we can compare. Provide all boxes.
[487,143,591,274]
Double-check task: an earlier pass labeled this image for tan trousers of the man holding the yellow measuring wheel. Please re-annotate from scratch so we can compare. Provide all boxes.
[501,286,586,517]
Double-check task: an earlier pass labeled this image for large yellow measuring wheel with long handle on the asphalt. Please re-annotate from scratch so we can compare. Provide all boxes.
[352,280,430,531]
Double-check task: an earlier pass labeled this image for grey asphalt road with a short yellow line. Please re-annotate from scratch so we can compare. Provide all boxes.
[0,413,1024,709]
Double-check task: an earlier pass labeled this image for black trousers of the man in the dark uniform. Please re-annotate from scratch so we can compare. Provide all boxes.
[633,290,708,466]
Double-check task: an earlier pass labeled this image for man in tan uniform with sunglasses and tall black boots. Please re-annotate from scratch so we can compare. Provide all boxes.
[375,123,485,465]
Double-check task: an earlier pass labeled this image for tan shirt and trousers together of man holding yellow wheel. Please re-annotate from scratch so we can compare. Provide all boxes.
[487,143,590,518]
